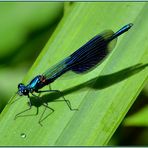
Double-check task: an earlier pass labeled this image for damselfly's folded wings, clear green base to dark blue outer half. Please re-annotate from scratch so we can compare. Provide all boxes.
[43,30,116,79]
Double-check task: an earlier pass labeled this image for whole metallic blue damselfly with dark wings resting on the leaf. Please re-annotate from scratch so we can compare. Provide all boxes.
[15,23,133,124]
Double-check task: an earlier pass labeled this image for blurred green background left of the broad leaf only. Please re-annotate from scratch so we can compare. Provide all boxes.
[0,2,64,108]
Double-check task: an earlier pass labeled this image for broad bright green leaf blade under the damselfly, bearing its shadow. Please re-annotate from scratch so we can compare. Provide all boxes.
[0,2,148,146]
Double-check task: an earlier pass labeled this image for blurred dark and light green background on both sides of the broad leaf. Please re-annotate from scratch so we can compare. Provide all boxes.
[0,2,148,146]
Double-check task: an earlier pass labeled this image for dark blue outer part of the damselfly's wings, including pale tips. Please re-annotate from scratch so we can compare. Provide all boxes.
[66,30,116,73]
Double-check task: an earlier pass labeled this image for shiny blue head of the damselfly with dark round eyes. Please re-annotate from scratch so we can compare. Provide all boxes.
[17,83,29,96]
